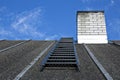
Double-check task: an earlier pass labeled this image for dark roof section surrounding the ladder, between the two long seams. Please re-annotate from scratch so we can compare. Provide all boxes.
[21,45,105,80]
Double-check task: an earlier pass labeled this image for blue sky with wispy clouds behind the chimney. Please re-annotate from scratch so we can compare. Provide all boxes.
[0,0,120,40]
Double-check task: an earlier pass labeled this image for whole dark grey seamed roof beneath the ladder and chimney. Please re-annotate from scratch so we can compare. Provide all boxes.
[0,40,120,80]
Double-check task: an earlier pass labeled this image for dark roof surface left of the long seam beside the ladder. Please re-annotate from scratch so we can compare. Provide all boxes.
[0,41,54,80]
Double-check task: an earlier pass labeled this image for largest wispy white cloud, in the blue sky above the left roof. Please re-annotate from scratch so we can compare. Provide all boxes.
[11,8,45,38]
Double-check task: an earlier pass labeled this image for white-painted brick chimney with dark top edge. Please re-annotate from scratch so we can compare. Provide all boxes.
[77,11,108,44]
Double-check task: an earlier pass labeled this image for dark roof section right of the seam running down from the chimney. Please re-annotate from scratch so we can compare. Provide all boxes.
[88,44,120,80]
